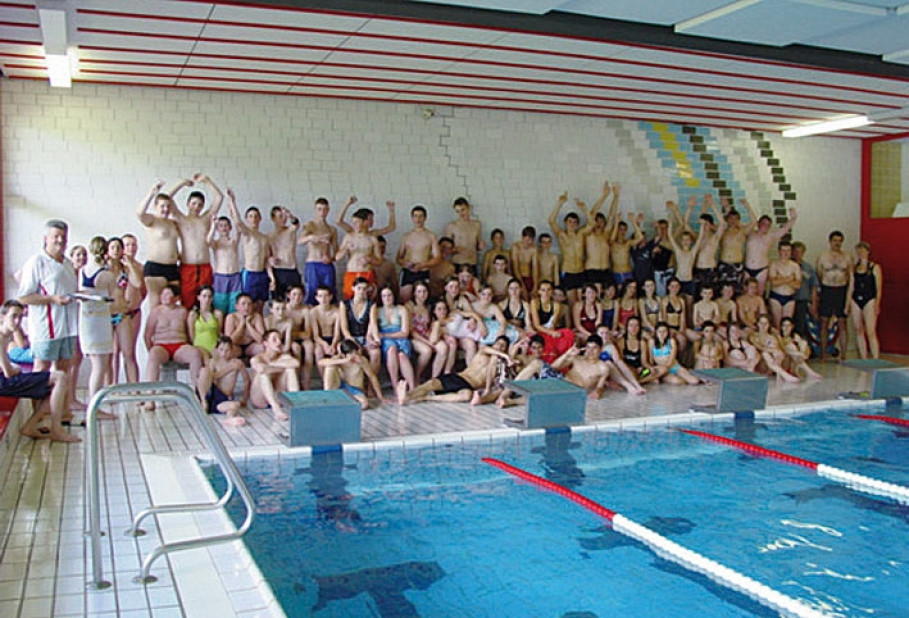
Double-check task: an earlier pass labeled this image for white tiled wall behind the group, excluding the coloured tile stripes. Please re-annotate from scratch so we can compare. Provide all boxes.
[0,81,860,292]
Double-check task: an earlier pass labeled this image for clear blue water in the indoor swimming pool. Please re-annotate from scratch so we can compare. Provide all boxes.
[208,412,909,618]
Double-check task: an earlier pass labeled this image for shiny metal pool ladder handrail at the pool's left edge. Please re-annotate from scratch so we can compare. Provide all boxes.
[85,382,255,590]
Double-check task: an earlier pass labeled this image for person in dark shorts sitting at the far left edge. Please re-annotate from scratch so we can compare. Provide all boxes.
[0,300,80,442]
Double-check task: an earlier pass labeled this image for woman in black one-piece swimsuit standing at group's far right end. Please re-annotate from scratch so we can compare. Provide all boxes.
[848,242,884,358]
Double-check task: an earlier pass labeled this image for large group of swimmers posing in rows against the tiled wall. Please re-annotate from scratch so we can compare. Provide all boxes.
[7,174,882,437]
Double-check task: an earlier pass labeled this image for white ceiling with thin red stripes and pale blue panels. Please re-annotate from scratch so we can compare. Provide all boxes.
[0,0,909,136]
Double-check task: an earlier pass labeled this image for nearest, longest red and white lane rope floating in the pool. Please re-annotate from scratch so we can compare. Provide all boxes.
[483,457,827,618]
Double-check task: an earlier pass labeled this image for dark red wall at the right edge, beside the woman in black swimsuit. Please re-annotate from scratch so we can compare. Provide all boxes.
[860,133,909,354]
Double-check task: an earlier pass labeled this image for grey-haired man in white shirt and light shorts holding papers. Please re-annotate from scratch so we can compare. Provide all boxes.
[17,219,79,410]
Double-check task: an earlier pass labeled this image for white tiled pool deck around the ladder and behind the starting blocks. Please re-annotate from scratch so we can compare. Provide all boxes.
[0,356,909,618]
